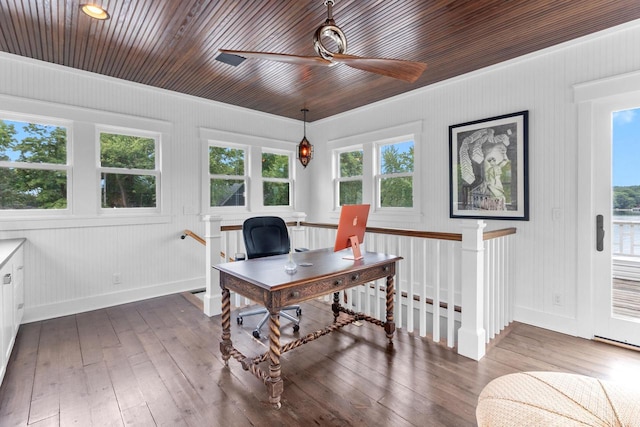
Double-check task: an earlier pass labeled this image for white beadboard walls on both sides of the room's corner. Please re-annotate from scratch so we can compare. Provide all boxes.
[0,17,640,334]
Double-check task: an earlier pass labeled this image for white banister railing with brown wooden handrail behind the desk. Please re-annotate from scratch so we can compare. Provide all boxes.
[205,220,515,360]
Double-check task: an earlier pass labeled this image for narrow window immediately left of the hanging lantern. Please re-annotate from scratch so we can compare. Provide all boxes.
[262,152,291,206]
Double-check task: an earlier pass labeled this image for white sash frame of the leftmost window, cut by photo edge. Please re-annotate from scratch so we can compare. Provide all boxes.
[0,110,73,218]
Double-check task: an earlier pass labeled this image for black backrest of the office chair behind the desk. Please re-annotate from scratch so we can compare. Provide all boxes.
[242,216,291,259]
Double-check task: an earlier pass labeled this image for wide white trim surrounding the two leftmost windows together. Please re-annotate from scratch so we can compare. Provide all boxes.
[0,94,175,231]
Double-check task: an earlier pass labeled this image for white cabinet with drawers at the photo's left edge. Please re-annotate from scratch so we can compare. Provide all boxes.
[0,239,25,390]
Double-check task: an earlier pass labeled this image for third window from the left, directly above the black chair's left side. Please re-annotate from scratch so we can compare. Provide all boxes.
[209,145,247,207]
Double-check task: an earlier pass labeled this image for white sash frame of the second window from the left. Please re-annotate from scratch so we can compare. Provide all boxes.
[95,125,163,215]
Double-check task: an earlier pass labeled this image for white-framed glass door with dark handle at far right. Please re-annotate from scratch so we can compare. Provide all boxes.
[593,100,640,346]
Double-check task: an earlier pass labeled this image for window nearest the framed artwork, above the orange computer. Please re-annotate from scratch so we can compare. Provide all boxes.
[376,140,414,208]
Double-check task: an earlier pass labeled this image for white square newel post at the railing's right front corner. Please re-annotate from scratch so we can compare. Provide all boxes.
[458,221,487,360]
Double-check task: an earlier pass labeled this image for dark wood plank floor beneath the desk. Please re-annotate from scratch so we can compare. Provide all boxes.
[0,295,640,427]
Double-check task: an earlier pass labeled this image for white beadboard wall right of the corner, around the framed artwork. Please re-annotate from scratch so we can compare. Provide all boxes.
[308,21,640,335]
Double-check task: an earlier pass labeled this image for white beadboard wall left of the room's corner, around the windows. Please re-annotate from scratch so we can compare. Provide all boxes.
[0,53,306,322]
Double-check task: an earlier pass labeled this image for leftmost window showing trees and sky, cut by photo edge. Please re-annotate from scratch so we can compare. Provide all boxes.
[0,120,70,210]
